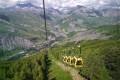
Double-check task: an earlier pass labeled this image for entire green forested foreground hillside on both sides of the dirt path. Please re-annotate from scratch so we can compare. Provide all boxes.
[0,40,120,80]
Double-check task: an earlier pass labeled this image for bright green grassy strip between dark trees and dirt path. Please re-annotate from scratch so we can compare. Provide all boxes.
[48,51,73,80]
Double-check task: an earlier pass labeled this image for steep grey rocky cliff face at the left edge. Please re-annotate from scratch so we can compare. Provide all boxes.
[0,34,34,50]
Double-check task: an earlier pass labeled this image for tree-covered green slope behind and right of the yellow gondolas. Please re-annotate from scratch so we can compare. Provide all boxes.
[51,40,120,80]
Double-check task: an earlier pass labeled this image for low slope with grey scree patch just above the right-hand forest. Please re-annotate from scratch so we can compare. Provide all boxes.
[58,24,120,45]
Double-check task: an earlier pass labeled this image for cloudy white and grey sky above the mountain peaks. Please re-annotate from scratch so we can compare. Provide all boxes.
[0,0,120,9]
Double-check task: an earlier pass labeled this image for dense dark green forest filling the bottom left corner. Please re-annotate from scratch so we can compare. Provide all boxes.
[0,54,46,80]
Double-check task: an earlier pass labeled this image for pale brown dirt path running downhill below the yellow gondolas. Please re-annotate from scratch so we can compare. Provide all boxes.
[56,62,83,80]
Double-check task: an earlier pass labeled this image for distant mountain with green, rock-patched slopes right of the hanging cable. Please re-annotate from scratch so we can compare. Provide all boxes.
[54,5,120,32]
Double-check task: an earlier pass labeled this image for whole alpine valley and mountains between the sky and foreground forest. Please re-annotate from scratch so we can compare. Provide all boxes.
[0,3,120,61]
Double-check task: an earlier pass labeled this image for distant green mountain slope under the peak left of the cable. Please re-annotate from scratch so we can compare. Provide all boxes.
[0,4,63,43]
